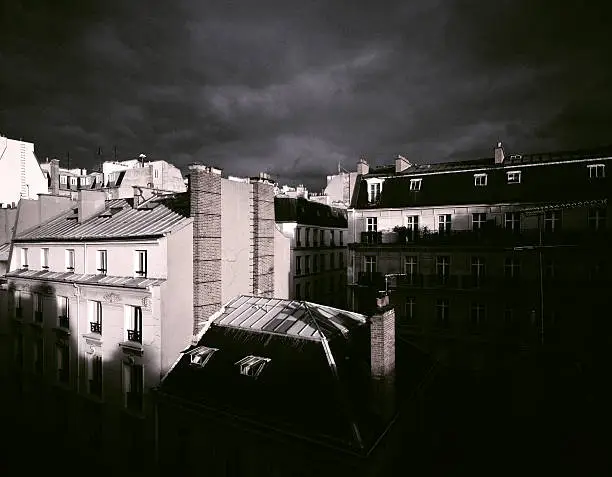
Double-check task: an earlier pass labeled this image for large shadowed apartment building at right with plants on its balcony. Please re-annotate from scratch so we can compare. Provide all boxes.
[348,144,612,366]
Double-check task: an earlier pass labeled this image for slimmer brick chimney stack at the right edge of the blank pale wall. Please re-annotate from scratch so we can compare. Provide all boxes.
[251,175,276,297]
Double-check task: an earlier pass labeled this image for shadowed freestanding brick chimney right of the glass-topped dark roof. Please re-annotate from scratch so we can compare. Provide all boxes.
[369,295,395,420]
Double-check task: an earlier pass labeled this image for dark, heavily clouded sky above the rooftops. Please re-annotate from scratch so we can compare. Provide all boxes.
[0,0,612,188]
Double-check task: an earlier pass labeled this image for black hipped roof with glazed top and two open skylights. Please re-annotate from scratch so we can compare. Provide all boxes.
[159,295,389,453]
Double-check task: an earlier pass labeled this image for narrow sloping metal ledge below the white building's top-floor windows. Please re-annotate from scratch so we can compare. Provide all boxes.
[6,269,166,288]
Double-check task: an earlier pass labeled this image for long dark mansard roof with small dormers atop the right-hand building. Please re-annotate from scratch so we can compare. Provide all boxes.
[352,155,612,209]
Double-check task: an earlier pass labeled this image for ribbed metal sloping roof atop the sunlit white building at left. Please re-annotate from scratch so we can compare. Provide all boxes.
[15,199,191,242]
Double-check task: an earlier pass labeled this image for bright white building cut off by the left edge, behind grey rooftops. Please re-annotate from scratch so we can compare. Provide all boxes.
[0,135,48,208]
